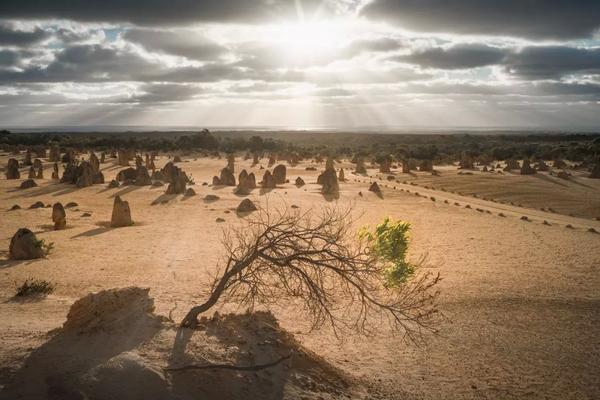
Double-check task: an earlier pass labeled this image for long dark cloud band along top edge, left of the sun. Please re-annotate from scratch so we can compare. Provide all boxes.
[0,0,339,25]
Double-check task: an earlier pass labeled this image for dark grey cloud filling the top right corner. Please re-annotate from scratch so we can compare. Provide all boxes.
[361,0,600,39]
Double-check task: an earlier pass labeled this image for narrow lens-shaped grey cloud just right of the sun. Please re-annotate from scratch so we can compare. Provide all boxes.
[393,44,506,69]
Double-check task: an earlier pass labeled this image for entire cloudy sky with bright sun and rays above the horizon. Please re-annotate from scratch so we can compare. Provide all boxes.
[0,0,600,129]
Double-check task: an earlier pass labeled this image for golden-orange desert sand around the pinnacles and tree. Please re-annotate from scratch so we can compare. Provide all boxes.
[0,154,600,399]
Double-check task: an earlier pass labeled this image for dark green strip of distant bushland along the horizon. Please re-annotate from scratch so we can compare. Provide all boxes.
[0,129,600,163]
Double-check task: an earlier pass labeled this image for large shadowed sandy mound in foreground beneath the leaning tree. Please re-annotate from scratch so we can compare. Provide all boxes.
[0,287,366,400]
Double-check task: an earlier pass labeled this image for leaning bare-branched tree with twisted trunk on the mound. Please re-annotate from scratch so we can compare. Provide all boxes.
[181,208,439,340]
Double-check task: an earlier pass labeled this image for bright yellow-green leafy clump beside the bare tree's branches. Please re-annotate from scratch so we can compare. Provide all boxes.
[359,217,415,287]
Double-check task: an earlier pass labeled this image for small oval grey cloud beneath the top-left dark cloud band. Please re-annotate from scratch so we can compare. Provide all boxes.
[123,29,227,60]
